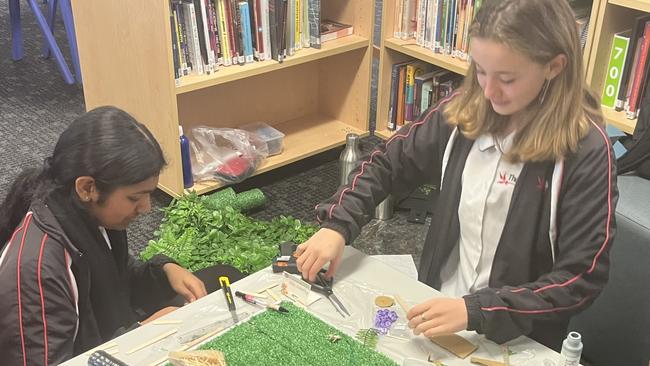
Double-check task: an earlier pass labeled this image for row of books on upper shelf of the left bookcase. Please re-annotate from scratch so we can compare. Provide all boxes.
[170,0,353,83]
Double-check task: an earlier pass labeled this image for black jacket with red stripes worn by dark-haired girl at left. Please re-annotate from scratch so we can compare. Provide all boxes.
[0,203,171,366]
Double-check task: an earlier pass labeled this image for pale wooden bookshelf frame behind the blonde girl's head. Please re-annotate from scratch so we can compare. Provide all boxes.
[375,0,604,139]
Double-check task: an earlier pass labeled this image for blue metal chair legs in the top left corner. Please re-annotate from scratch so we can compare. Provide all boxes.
[9,0,76,84]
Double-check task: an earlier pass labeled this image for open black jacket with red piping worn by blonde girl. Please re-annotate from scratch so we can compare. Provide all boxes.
[316,95,618,349]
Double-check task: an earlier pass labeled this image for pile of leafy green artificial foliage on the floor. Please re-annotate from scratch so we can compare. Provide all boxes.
[140,193,317,273]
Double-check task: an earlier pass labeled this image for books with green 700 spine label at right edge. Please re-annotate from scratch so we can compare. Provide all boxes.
[601,14,650,119]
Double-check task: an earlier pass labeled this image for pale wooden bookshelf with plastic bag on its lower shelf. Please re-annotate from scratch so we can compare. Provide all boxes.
[72,0,374,196]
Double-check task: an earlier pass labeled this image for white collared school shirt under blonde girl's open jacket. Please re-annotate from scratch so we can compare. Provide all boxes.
[440,133,523,297]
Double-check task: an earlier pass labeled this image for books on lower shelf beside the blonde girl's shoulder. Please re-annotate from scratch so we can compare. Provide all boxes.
[388,61,463,130]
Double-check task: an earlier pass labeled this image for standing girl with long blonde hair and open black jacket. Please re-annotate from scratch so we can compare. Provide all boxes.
[297,0,617,349]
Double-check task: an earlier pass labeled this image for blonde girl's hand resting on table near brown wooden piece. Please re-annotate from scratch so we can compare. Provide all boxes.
[406,298,467,338]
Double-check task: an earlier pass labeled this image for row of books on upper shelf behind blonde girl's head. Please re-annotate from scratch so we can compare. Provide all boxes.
[393,0,592,60]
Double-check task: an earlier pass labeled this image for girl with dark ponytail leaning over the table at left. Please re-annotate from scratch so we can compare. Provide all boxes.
[0,107,206,365]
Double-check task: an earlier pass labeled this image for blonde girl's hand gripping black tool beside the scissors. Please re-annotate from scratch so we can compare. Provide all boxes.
[296,228,345,282]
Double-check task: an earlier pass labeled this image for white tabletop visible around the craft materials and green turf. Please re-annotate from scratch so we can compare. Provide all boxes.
[64,247,558,366]
